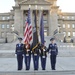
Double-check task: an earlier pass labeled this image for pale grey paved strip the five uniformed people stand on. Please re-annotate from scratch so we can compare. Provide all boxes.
[0,57,75,71]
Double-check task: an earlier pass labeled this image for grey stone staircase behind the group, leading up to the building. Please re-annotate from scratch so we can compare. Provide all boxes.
[0,37,75,58]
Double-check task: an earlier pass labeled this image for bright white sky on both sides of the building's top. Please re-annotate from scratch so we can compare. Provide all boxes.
[0,0,75,13]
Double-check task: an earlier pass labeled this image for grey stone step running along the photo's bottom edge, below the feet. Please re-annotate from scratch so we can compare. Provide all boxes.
[0,70,75,75]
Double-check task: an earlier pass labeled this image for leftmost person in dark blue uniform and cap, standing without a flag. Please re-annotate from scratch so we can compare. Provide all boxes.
[15,38,23,70]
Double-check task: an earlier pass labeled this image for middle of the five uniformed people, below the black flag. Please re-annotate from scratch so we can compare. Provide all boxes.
[32,47,39,70]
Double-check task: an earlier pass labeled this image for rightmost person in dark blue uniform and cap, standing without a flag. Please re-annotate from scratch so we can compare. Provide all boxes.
[48,38,58,70]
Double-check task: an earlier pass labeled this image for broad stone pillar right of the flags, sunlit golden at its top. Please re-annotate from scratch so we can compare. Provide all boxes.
[49,6,58,36]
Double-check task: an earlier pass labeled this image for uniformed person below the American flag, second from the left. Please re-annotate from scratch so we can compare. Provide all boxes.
[24,44,31,70]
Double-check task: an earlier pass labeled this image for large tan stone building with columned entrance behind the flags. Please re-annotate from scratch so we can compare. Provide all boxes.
[0,0,75,42]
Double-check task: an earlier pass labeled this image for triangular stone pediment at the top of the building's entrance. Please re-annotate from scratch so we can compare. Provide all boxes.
[19,0,51,5]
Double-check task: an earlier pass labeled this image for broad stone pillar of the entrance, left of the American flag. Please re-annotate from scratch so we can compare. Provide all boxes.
[14,7,22,35]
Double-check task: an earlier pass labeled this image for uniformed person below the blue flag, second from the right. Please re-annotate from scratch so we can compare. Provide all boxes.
[40,45,47,70]
